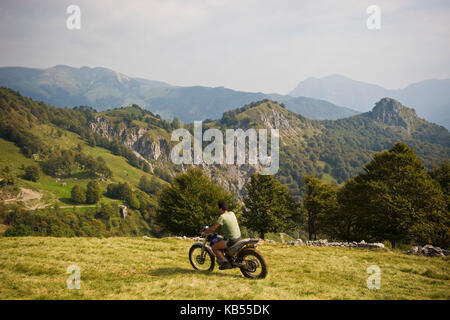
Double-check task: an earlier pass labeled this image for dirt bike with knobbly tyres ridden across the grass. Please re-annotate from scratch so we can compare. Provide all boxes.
[189,227,268,279]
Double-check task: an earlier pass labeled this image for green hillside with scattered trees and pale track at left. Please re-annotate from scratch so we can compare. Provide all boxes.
[0,89,176,236]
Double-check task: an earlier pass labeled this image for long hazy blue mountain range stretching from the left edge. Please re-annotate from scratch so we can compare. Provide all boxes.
[0,66,358,122]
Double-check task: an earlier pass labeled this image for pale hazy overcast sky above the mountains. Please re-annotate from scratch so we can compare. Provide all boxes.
[0,0,450,94]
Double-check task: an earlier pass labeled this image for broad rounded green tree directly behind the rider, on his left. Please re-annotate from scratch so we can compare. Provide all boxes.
[156,168,237,236]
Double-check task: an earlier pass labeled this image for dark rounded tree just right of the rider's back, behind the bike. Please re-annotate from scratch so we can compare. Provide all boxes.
[242,173,300,239]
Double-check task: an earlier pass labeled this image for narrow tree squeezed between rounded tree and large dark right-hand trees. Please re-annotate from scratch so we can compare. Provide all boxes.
[303,176,339,240]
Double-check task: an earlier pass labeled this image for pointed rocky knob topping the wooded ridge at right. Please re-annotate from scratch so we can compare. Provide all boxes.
[368,98,418,130]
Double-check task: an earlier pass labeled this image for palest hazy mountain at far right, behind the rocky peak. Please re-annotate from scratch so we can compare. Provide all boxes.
[289,75,450,128]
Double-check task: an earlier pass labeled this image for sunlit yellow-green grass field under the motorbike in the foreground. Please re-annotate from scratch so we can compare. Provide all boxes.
[0,237,450,299]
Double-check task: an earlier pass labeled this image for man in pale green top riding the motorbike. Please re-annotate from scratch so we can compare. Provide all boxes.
[202,200,241,270]
